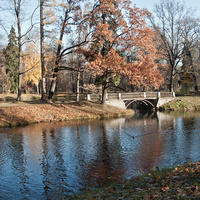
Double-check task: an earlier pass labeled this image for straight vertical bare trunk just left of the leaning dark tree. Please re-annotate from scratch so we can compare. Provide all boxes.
[40,0,46,99]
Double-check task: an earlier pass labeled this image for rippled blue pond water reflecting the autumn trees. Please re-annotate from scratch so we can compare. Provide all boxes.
[0,113,200,200]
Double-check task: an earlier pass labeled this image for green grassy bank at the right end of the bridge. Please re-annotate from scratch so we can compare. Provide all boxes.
[160,96,200,111]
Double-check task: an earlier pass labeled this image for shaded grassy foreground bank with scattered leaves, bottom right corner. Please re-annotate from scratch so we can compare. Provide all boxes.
[70,162,200,200]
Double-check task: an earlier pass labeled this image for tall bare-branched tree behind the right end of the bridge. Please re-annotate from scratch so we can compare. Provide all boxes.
[151,0,197,91]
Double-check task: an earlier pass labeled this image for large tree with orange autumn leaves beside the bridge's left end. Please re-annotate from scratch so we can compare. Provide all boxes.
[82,0,163,104]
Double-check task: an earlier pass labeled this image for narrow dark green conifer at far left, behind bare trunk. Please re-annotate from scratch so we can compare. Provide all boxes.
[4,27,19,92]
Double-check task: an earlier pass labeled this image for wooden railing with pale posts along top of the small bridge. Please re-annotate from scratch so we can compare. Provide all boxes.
[87,92,175,101]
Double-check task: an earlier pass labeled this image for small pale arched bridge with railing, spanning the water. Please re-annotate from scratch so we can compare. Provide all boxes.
[87,92,175,109]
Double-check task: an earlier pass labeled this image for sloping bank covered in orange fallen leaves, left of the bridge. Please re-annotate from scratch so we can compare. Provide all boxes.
[0,102,135,128]
